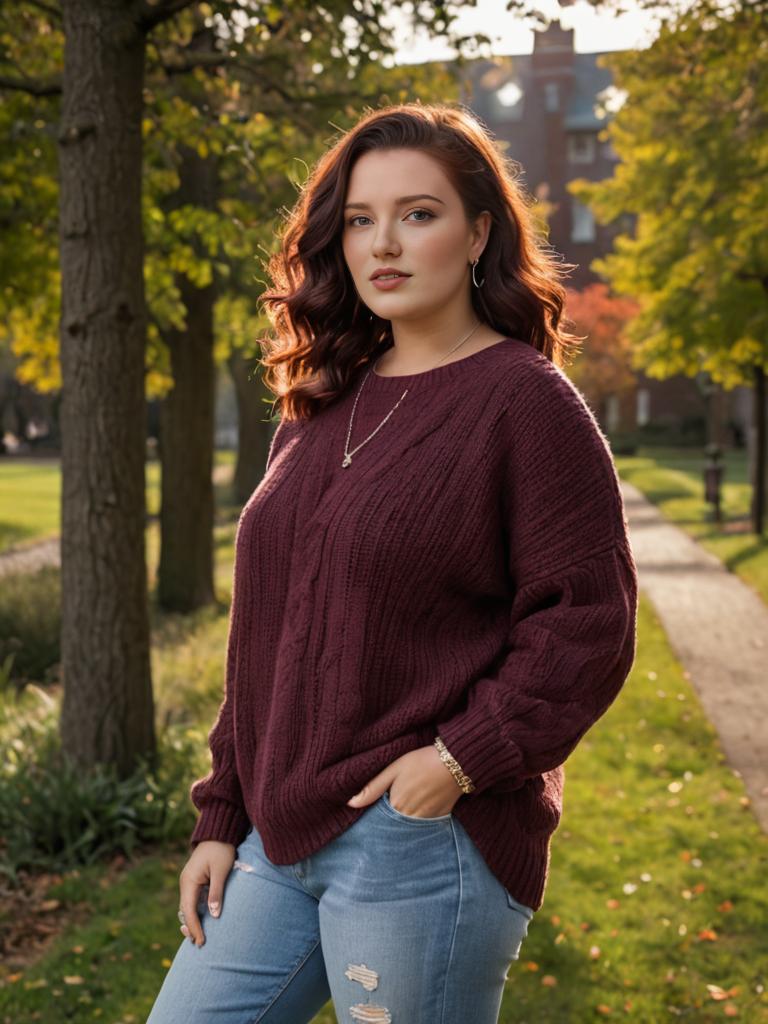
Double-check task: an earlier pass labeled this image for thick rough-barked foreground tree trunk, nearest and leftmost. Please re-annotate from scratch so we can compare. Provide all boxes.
[58,0,155,776]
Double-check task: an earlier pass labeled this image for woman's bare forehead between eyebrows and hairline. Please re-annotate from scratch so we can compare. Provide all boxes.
[345,148,459,203]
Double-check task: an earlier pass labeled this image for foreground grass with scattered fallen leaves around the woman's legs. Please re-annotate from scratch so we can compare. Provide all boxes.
[0,598,768,1024]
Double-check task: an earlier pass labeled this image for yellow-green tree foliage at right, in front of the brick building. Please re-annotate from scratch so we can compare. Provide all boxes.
[569,0,768,387]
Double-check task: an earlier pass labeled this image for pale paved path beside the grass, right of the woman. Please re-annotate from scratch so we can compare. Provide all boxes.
[622,480,768,831]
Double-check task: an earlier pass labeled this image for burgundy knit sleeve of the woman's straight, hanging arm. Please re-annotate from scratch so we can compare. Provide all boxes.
[189,411,292,847]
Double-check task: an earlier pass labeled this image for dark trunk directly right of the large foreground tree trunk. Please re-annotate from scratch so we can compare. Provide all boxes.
[158,146,216,612]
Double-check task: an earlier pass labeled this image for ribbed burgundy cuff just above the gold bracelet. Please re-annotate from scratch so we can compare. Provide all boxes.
[437,705,522,797]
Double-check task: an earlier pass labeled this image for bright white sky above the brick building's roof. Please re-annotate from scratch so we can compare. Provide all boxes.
[396,0,656,63]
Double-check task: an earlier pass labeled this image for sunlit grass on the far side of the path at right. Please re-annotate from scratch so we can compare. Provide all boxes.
[615,447,768,602]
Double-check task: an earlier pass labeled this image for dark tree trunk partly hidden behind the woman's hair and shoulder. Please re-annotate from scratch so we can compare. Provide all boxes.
[227,351,274,505]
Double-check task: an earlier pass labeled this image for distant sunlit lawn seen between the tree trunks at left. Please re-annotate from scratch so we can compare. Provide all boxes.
[0,451,234,552]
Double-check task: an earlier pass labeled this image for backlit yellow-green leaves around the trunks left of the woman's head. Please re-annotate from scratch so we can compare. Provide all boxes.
[0,0,475,397]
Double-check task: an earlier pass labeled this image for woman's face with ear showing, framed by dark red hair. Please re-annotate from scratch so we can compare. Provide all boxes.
[342,148,489,321]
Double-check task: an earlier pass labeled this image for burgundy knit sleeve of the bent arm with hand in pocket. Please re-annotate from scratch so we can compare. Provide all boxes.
[437,356,638,799]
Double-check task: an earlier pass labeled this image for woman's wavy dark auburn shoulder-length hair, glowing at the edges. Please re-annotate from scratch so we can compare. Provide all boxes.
[259,101,581,420]
